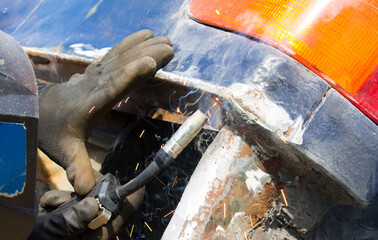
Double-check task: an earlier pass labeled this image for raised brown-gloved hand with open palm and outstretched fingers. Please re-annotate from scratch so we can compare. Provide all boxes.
[38,30,173,195]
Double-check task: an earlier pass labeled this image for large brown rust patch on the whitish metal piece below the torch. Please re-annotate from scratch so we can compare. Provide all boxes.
[181,172,282,239]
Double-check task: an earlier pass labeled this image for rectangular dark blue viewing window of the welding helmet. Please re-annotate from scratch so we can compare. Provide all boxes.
[0,122,26,196]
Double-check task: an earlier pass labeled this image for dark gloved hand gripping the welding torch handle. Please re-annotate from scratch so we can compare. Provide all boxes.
[28,188,144,240]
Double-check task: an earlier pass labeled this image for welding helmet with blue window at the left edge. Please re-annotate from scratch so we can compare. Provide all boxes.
[0,31,38,239]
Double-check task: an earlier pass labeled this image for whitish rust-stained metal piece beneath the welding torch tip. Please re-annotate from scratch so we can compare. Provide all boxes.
[162,128,279,239]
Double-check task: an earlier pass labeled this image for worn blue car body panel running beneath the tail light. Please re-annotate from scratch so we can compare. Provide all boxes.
[0,0,378,209]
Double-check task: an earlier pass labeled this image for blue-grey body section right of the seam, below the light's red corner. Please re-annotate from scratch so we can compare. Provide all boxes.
[298,89,378,206]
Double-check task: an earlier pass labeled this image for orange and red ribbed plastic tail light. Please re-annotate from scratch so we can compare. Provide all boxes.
[190,0,378,122]
